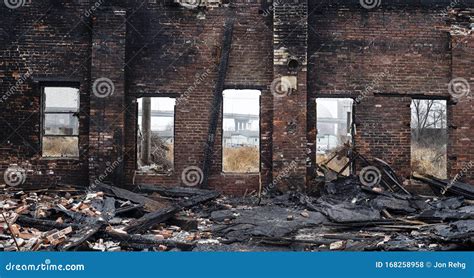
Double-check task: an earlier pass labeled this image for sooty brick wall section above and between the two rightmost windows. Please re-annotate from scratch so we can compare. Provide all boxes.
[308,1,473,185]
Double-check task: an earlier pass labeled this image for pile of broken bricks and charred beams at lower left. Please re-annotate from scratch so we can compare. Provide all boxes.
[0,184,219,251]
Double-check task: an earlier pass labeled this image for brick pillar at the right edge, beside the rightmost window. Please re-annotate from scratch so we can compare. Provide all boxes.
[447,35,474,183]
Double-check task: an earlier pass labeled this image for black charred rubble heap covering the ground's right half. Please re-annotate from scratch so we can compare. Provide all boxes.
[211,177,474,251]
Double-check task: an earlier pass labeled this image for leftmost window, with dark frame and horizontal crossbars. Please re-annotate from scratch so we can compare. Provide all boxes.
[40,82,80,159]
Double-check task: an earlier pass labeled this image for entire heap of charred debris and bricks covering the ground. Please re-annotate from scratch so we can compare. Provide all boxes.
[0,169,474,251]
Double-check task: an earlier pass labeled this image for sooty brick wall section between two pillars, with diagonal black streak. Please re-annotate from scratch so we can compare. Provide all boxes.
[122,1,273,195]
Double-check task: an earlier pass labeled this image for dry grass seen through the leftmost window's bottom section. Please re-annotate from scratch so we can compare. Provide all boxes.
[43,137,79,157]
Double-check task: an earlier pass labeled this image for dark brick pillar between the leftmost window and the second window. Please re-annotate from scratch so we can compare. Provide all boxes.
[89,7,126,185]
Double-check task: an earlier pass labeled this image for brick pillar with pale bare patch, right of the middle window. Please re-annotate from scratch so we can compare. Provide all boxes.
[271,0,308,190]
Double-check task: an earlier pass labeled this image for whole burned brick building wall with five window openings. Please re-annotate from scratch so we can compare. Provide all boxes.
[0,0,474,195]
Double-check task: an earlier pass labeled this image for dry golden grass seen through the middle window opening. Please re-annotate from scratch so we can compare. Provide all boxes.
[223,147,260,173]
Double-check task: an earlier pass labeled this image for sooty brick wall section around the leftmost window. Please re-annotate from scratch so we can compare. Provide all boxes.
[0,1,91,188]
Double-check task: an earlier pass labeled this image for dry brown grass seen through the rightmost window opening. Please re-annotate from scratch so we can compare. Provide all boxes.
[411,145,447,179]
